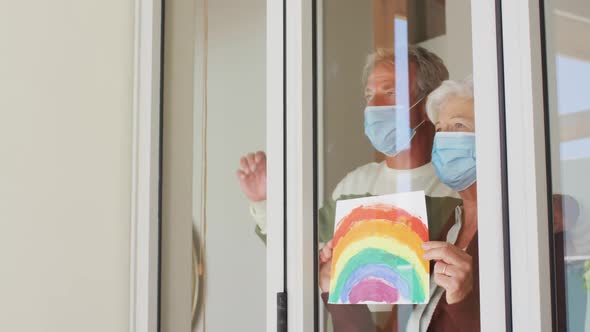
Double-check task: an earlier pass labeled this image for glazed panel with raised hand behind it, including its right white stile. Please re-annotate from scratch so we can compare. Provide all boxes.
[160,0,284,331]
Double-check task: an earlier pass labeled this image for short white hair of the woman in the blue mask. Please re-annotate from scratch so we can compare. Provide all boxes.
[426,77,473,123]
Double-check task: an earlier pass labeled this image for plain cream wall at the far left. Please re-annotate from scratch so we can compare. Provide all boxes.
[0,0,134,332]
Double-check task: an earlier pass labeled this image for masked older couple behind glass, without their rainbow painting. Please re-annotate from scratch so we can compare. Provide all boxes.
[237,42,580,332]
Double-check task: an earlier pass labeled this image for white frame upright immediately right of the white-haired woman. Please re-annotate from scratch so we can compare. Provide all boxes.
[471,0,510,331]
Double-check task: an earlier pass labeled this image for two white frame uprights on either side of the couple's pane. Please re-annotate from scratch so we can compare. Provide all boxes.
[280,0,509,331]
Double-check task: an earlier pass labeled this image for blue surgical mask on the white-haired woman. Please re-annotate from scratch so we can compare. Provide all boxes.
[432,132,477,191]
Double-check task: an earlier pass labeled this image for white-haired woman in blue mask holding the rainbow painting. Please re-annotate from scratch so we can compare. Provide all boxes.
[320,81,480,332]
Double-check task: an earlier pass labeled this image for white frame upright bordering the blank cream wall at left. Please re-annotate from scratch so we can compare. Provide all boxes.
[129,0,162,332]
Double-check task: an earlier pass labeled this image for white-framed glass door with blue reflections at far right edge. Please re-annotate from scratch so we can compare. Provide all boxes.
[502,0,590,331]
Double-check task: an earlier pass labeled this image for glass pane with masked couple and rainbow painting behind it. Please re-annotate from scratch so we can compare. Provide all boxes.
[316,0,480,331]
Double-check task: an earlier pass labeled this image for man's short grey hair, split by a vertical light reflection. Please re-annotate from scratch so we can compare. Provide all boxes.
[363,45,449,98]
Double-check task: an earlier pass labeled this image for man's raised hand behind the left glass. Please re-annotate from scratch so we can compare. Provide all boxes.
[236,151,266,202]
